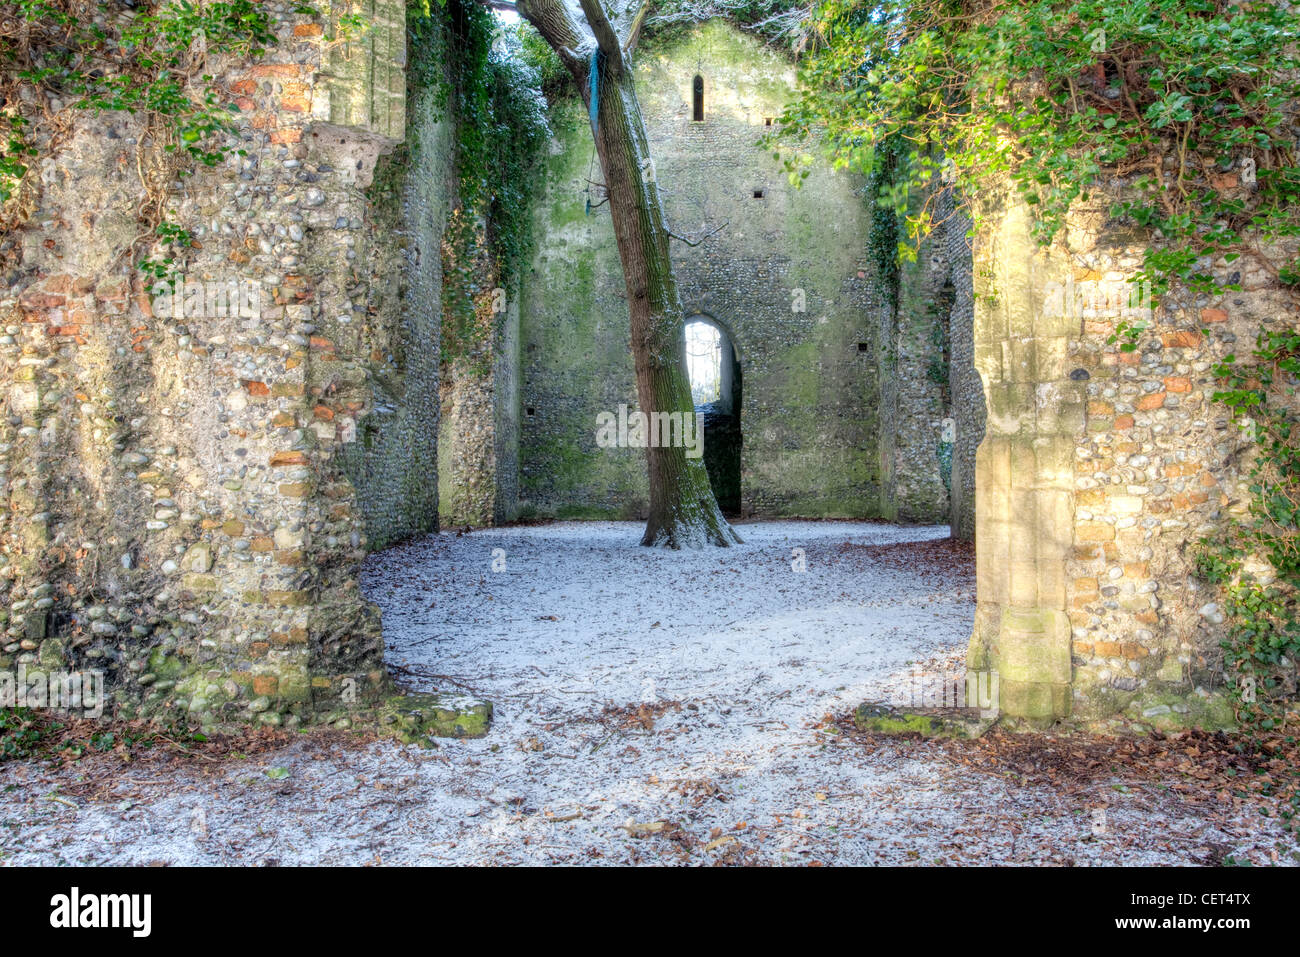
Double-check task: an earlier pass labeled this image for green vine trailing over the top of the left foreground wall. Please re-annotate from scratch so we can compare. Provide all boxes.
[0,0,364,278]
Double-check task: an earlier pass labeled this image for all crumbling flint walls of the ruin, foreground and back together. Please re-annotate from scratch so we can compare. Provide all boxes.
[0,0,1283,724]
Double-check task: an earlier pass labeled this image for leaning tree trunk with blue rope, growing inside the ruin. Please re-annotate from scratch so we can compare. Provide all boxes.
[504,0,740,549]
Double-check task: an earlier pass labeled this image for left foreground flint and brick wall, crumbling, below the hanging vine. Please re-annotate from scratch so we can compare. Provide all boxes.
[0,4,428,723]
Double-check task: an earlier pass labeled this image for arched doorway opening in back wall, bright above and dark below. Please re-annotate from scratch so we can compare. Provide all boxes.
[685,316,742,515]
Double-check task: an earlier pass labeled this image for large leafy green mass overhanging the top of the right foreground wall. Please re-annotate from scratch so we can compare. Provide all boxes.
[771,0,1300,296]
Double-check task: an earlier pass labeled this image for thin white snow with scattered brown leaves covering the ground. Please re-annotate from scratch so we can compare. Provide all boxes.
[0,521,1279,865]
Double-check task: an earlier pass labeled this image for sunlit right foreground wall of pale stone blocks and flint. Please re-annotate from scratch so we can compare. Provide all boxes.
[969,180,1290,724]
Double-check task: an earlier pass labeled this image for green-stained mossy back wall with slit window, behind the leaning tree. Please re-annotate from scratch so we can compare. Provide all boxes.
[519,21,904,518]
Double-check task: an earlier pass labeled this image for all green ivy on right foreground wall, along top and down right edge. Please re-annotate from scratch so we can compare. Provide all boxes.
[767,0,1300,729]
